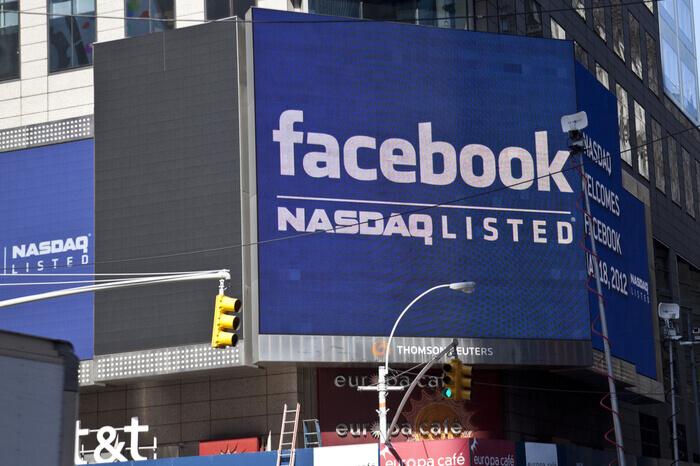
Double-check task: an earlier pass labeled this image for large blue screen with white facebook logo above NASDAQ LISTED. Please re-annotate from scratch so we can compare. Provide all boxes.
[252,9,590,362]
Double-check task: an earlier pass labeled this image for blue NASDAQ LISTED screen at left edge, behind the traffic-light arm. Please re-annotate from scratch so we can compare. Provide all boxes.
[0,140,95,359]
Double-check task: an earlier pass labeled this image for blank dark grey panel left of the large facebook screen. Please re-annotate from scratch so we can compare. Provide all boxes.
[94,23,241,354]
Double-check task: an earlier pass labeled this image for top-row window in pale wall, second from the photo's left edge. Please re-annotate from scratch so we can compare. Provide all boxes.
[49,0,95,71]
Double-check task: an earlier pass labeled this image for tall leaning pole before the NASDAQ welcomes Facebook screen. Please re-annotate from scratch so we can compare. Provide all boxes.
[579,153,626,466]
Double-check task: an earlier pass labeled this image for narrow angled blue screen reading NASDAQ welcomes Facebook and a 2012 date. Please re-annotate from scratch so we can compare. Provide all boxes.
[576,63,656,378]
